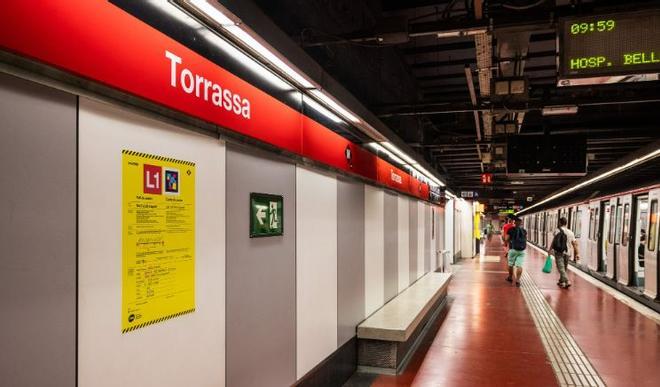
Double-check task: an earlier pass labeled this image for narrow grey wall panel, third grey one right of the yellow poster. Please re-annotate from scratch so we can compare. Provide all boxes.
[383,192,399,302]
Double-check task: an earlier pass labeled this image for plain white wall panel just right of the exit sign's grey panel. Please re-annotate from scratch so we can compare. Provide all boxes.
[296,167,338,378]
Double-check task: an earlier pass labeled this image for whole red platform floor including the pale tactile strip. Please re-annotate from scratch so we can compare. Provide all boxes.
[346,237,660,387]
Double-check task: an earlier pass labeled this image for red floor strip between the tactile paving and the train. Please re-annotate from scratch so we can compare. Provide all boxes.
[526,248,660,387]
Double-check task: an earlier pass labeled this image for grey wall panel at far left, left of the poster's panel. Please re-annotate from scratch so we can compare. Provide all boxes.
[0,74,77,387]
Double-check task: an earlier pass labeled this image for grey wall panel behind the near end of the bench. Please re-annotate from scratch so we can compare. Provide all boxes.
[337,179,365,346]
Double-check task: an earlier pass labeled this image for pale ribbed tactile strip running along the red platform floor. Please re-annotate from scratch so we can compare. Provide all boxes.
[521,272,605,387]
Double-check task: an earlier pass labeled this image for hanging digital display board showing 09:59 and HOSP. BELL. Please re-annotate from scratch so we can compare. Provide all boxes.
[559,10,660,86]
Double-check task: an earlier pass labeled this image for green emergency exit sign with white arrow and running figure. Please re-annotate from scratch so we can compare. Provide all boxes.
[250,192,284,238]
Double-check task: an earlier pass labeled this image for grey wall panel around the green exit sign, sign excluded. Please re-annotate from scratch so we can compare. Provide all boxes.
[228,145,296,386]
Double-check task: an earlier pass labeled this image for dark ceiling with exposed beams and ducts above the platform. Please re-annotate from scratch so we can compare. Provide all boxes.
[255,0,660,208]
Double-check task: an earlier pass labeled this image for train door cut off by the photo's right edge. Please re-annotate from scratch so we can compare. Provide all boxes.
[644,189,660,299]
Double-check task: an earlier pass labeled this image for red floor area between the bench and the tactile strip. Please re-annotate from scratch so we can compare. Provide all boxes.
[373,240,557,387]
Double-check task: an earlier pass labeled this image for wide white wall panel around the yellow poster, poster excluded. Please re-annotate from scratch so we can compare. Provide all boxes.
[78,98,224,387]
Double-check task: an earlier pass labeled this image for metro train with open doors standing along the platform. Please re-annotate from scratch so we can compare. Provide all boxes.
[521,185,660,301]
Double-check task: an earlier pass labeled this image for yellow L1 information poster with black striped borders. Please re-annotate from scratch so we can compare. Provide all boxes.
[121,150,195,333]
